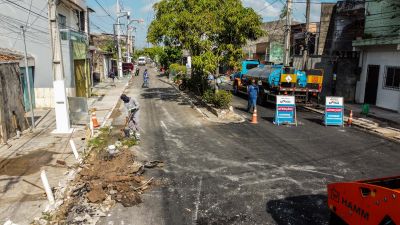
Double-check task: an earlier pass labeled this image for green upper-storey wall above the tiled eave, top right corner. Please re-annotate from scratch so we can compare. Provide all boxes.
[364,0,400,38]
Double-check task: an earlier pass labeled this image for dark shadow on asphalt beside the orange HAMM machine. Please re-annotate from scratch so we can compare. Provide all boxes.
[266,195,329,225]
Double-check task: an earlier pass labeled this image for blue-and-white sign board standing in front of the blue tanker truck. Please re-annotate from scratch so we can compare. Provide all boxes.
[274,95,297,126]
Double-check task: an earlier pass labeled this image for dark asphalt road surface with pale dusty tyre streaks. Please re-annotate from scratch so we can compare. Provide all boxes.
[100,68,400,225]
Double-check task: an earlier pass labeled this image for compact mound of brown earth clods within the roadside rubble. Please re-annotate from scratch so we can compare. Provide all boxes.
[77,150,151,207]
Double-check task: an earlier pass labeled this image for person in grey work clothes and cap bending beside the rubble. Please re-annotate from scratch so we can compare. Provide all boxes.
[120,94,140,139]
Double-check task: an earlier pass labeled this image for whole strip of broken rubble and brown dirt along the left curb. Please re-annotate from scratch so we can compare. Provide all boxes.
[34,127,163,224]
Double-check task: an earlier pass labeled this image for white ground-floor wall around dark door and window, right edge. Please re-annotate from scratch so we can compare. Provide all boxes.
[356,46,400,112]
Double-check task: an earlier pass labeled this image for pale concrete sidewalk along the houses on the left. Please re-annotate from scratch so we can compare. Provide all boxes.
[0,79,128,225]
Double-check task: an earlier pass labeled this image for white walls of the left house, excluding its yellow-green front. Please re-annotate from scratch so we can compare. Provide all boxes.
[0,0,86,108]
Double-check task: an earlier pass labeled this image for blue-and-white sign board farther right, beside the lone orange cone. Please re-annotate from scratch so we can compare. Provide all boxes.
[324,97,344,126]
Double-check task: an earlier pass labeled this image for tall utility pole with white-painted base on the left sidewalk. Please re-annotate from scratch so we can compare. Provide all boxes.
[48,0,71,133]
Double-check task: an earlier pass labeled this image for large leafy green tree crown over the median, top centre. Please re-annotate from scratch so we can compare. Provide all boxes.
[147,0,263,75]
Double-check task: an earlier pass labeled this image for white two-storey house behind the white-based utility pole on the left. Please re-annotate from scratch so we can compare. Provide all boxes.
[0,0,90,107]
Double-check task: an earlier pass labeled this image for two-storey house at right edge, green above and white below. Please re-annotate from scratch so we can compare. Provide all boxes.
[353,0,400,112]
